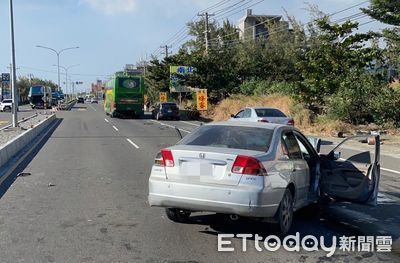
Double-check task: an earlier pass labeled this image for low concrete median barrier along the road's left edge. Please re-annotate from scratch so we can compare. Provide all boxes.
[0,114,56,183]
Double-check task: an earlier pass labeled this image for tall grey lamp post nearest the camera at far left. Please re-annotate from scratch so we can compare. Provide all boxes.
[10,0,18,128]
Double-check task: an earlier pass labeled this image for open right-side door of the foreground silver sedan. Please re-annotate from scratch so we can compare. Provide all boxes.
[320,135,380,205]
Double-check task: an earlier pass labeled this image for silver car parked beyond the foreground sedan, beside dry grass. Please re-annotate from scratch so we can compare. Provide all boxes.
[230,107,294,126]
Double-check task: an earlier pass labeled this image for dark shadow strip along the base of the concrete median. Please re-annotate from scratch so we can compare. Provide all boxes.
[0,118,63,198]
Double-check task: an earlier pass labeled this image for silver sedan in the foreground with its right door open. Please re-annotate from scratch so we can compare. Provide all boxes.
[149,121,380,234]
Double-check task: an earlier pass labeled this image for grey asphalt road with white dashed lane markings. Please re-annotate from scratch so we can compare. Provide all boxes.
[0,104,400,262]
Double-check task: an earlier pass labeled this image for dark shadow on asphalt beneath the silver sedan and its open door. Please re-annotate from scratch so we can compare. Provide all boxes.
[184,202,400,245]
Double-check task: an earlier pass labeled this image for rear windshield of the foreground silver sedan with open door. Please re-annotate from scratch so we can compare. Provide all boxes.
[178,125,273,152]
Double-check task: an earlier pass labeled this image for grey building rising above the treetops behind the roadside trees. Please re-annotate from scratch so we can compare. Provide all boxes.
[239,9,290,40]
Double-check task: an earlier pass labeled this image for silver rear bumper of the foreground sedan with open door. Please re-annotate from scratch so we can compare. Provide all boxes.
[149,178,279,218]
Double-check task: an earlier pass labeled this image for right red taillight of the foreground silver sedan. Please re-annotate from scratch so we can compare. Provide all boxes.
[232,155,267,176]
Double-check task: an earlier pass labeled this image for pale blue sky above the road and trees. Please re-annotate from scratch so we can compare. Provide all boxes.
[0,0,385,94]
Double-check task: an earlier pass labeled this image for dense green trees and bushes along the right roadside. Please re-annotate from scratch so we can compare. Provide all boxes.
[147,0,400,126]
